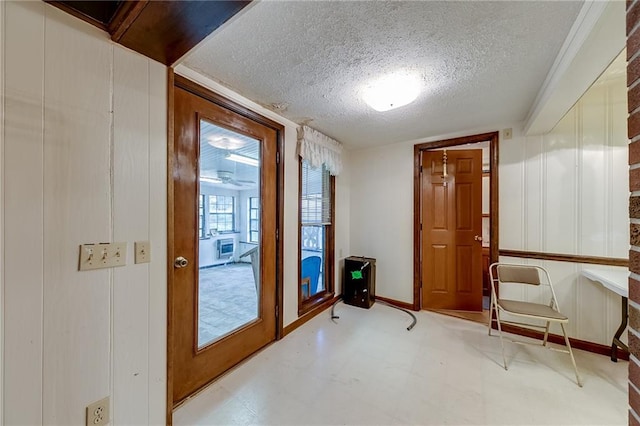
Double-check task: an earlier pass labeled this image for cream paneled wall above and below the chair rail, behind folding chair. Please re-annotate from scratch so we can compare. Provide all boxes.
[500,54,629,345]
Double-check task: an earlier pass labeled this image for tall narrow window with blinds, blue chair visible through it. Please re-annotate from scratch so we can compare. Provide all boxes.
[298,160,335,314]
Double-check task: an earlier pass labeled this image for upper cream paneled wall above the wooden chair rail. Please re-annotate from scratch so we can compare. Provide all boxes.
[500,80,629,258]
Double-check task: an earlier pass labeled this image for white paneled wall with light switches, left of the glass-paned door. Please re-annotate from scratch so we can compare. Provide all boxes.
[0,2,167,425]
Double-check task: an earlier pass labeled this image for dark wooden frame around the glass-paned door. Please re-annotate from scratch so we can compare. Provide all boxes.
[167,68,285,425]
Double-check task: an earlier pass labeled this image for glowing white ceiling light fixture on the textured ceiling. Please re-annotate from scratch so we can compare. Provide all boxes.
[363,73,420,112]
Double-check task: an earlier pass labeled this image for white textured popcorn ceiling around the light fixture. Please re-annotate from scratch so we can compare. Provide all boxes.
[183,1,582,148]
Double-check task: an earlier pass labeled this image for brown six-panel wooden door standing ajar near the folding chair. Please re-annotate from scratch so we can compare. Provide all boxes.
[421,150,482,311]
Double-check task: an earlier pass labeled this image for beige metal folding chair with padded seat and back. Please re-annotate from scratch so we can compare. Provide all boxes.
[489,263,582,387]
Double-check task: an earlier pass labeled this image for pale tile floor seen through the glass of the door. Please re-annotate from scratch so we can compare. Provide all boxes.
[198,263,258,346]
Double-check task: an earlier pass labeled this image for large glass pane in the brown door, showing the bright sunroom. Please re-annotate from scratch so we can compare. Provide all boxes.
[197,120,260,349]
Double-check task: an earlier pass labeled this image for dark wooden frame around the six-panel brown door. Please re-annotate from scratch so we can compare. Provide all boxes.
[413,132,500,311]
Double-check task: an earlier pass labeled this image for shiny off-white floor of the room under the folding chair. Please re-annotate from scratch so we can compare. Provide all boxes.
[173,303,628,425]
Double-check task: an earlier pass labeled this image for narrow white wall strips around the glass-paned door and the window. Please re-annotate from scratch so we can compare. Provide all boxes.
[176,66,350,327]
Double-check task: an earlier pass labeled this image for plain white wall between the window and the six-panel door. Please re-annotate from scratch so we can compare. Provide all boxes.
[346,143,413,303]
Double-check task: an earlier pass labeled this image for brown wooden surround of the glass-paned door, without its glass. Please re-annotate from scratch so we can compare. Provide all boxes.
[169,88,278,404]
